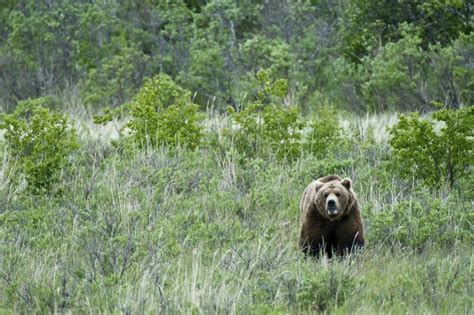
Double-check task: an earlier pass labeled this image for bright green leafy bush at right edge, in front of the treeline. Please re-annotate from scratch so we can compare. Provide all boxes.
[389,106,474,188]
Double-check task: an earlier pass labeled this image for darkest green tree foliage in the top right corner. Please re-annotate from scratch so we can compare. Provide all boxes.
[338,0,473,62]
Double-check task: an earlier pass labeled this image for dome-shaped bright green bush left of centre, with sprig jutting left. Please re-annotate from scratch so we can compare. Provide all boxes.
[95,74,203,149]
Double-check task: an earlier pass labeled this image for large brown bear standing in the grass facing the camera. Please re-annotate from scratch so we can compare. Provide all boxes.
[299,175,364,258]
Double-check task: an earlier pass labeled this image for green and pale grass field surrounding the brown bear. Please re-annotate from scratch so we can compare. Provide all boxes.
[0,112,474,314]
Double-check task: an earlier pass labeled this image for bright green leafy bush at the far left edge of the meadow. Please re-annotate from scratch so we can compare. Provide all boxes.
[0,99,77,194]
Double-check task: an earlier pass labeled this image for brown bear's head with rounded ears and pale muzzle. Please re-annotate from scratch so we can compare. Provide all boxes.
[314,178,356,221]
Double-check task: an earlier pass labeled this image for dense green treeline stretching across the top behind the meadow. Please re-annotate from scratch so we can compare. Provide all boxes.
[0,0,474,112]
